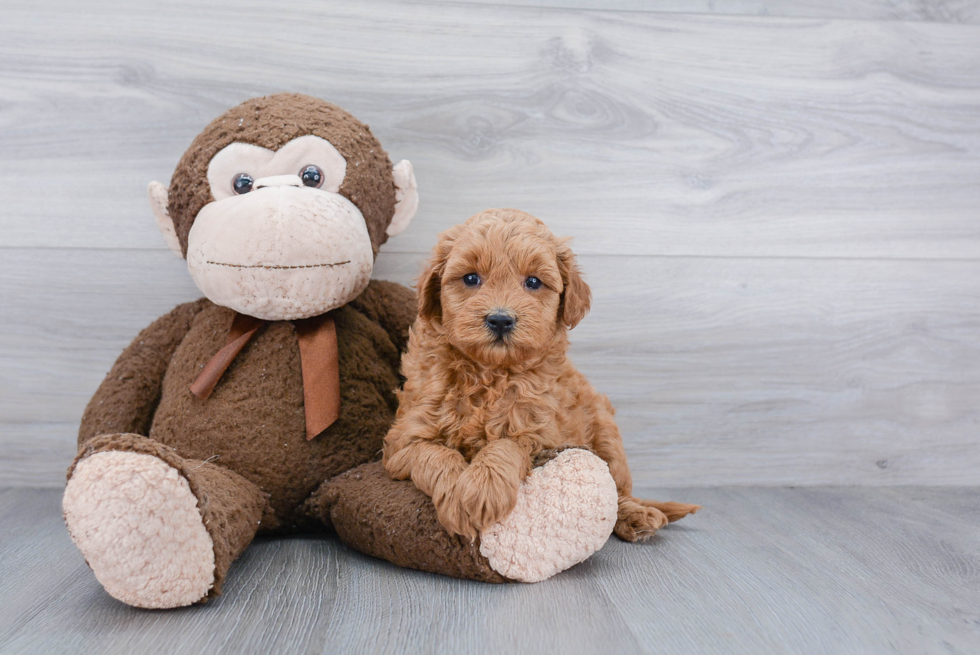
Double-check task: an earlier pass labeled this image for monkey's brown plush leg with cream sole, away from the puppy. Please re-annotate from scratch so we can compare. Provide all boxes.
[63,434,267,608]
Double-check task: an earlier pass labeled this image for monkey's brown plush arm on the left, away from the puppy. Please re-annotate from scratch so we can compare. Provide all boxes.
[78,298,208,446]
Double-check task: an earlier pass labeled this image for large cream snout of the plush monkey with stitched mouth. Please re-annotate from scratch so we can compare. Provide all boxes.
[187,186,374,321]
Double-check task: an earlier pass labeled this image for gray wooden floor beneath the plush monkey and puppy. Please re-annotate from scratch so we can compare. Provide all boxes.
[0,487,980,655]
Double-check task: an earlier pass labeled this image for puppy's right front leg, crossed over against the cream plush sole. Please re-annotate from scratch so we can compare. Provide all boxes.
[455,439,531,538]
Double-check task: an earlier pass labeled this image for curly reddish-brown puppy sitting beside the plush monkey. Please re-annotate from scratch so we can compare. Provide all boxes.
[383,209,700,541]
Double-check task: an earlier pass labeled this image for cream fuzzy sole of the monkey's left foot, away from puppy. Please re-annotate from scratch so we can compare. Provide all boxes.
[63,451,215,608]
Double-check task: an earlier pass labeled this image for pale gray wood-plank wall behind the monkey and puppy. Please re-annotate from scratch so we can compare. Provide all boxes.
[0,0,980,487]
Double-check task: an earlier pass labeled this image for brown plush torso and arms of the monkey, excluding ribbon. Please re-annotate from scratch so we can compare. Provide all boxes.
[79,283,414,530]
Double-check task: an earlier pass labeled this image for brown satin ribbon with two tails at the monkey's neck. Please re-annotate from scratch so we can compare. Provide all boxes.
[191,313,340,439]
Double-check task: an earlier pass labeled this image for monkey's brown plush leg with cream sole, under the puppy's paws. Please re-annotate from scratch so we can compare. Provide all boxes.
[307,449,617,582]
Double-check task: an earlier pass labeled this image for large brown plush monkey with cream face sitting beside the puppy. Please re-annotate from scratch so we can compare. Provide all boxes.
[63,94,615,608]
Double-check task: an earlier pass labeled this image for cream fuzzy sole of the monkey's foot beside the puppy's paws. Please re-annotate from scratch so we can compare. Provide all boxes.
[480,448,618,582]
